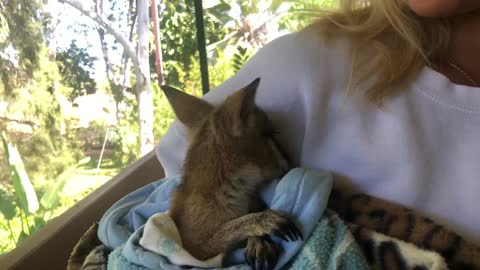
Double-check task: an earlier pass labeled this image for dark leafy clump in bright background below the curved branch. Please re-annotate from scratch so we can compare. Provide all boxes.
[56,40,97,100]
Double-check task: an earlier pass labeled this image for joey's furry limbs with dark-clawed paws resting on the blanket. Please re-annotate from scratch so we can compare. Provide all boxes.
[202,210,303,265]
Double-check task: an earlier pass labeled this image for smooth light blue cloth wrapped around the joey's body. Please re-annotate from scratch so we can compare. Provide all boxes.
[98,168,332,269]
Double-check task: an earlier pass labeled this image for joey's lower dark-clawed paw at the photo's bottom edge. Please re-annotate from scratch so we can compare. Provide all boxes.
[243,236,281,270]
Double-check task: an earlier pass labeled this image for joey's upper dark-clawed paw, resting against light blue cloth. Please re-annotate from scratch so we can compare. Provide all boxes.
[262,210,303,242]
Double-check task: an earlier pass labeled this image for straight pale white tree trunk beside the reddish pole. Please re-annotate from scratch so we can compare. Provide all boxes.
[136,0,154,156]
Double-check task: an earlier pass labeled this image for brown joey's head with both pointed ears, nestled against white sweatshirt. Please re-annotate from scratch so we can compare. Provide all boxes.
[162,79,288,182]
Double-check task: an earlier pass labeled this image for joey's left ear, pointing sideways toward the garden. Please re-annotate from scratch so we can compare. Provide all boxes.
[160,85,213,128]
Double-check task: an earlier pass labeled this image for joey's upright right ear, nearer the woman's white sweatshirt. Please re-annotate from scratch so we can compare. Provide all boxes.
[224,78,260,133]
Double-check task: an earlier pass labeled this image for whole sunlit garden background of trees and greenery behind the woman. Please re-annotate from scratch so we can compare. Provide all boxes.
[0,0,335,254]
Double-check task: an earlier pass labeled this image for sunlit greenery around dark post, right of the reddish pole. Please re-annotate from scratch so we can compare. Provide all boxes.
[155,0,318,91]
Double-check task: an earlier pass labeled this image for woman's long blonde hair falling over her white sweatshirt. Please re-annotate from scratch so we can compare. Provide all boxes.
[310,0,451,105]
